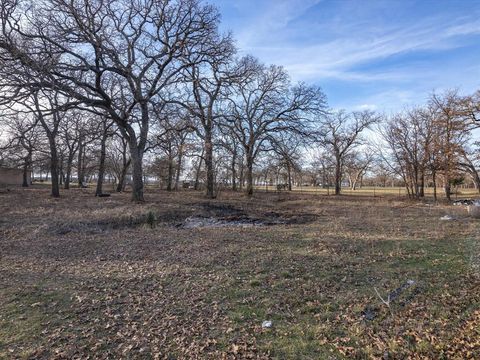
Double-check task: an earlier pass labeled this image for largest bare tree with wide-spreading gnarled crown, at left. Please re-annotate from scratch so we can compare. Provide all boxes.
[0,0,223,201]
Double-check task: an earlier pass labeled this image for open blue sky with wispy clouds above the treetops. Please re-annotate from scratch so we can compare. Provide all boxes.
[209,0,480,112]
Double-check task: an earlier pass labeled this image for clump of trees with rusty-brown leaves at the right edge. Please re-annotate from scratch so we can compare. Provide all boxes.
[379,91,480,200]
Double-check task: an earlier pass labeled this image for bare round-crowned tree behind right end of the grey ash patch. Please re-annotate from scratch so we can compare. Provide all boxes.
[226,57,326,196]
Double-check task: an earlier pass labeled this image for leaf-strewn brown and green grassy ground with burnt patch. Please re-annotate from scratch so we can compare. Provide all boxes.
[0,187,480,359]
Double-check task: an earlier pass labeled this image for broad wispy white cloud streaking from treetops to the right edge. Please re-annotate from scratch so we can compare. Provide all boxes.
[230,0,480,81]
